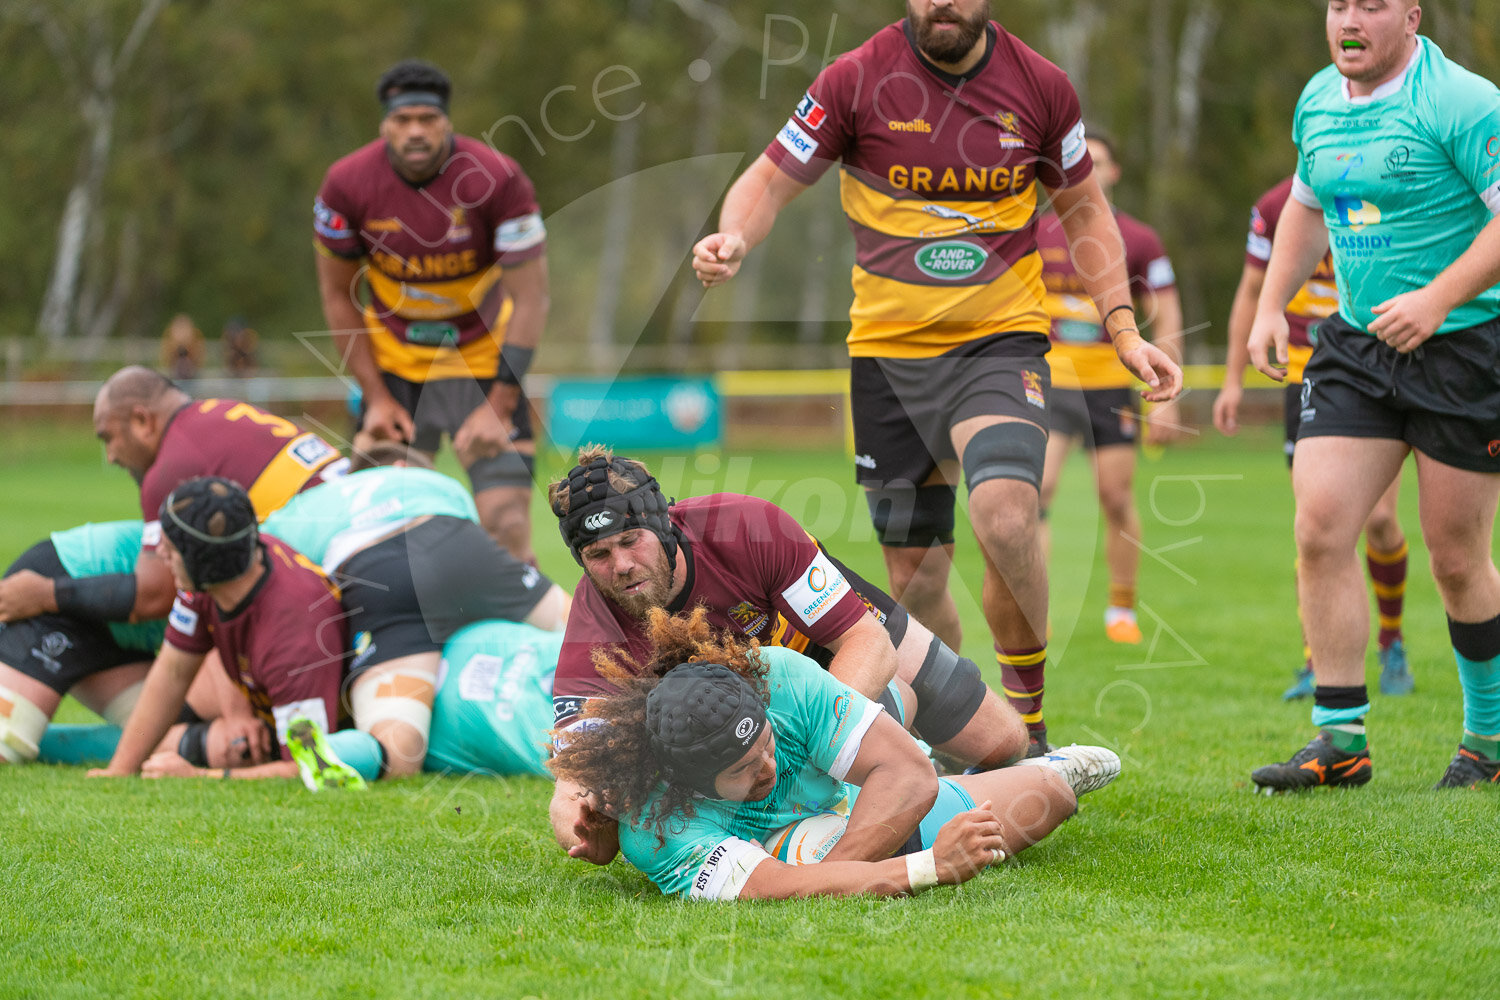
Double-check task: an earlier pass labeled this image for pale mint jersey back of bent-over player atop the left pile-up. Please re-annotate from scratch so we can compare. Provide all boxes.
[261,466,479,573]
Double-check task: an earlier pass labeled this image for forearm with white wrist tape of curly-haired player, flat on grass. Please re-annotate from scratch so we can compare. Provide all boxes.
[738,802,1007,900]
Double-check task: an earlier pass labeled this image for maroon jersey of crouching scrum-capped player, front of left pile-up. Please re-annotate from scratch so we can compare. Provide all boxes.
[167,535,350,760]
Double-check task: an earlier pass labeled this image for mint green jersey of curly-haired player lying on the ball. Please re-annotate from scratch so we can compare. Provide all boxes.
[620,646,881,900]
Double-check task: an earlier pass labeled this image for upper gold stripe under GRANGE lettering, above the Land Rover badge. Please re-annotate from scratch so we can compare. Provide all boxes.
[839,168,1037,240]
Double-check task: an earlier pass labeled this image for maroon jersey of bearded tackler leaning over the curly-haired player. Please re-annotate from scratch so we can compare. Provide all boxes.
[552,493,867,726]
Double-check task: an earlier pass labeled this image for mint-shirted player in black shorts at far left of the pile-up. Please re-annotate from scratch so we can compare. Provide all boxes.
[0,520,261,763]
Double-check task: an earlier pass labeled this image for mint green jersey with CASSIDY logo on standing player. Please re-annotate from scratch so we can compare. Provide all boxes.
[1292,36,1500,333]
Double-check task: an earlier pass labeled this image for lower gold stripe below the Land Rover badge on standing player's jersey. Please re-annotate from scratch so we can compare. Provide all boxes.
[849,250,1049,358]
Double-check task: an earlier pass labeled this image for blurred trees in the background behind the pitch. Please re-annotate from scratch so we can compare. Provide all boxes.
[0,0,1500,370]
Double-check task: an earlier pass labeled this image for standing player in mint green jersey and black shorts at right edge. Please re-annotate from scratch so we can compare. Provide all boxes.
[1250,0,1500,792]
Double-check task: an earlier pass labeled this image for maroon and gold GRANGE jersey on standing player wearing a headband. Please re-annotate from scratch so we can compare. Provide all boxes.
[314,135,546,382]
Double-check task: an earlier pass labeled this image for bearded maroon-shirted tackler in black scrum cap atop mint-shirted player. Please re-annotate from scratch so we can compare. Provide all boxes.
[549,445,1028,865]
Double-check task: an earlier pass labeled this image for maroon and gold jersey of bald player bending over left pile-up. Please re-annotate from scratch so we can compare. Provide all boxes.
[141,399,350,549]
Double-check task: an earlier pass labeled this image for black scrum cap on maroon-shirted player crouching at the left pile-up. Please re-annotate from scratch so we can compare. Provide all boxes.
[159,475,260,589]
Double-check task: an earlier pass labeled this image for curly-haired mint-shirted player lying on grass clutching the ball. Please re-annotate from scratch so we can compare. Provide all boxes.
[551,609,1119,900]
